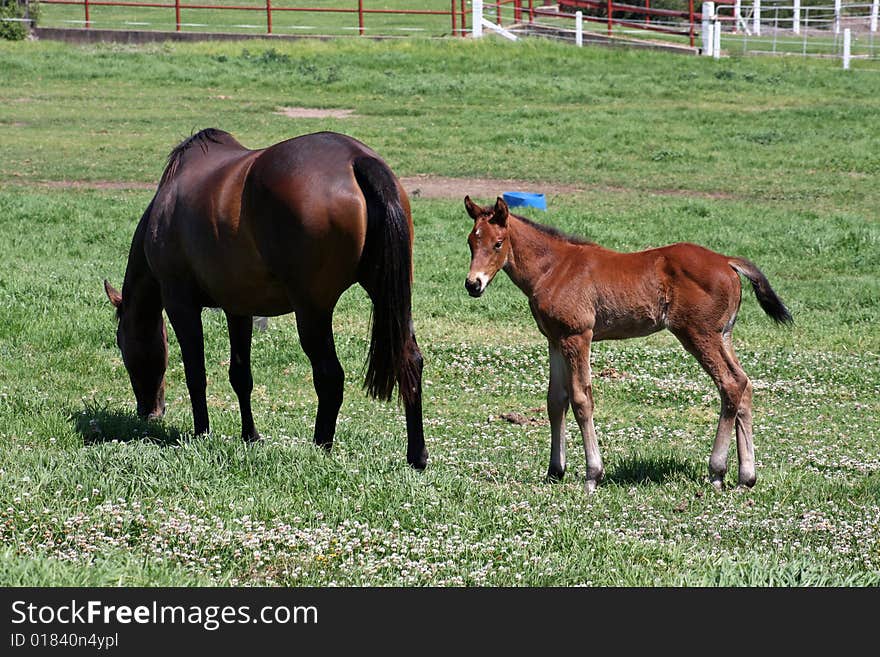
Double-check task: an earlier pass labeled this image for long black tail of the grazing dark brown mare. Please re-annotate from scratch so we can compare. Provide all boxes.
[352,156,421,401]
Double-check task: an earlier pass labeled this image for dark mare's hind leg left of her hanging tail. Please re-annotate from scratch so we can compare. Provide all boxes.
[296,310,345,451]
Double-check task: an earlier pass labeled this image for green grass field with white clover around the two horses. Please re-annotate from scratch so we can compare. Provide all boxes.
[0,34,880,586]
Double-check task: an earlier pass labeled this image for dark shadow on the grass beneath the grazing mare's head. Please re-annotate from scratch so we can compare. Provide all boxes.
[69,404,183,447]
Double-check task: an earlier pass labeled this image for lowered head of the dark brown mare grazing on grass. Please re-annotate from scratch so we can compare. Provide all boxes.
[104,281,168,420]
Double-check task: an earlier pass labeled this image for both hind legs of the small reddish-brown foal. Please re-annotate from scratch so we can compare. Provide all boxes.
[674,331,756,489]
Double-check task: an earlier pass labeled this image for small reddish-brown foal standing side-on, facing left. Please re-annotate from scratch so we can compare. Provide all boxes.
[464,197,792,492]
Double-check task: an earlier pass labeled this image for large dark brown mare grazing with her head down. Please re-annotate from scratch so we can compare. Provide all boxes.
[104,129,428,469]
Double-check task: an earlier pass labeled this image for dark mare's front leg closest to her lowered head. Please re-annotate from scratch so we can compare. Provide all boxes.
[165,297,209,435]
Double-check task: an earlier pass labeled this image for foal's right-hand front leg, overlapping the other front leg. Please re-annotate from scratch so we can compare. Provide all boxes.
[560,331,605,493]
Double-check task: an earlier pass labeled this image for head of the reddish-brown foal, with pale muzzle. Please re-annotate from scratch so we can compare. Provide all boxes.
[464,196,510,297]
